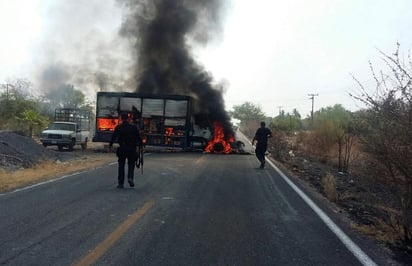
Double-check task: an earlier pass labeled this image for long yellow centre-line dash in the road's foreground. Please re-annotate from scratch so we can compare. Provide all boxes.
[75,200,154,266]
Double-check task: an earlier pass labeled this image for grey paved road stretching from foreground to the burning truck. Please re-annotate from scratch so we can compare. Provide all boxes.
[0,142,396,265]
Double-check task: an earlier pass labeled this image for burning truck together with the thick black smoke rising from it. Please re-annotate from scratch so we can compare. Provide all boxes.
[89,0,236,154]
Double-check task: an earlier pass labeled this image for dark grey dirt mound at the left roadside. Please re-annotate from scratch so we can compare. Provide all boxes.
[0,131,59,171]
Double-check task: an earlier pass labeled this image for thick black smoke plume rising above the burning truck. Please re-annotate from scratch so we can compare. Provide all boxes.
[119,0,233,140]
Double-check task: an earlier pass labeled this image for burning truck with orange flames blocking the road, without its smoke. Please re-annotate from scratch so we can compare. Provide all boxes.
[93,92,234,154]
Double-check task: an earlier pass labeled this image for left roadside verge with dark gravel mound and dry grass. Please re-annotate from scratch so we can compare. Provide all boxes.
[0,132,116,193]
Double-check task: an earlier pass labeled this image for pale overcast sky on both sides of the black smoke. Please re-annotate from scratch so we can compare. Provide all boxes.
[0,0,412,117]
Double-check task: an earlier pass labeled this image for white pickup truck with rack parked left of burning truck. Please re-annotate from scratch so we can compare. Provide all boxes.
[40,108,90,151]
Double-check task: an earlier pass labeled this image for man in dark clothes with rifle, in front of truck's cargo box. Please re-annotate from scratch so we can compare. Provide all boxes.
[109,114,142,188]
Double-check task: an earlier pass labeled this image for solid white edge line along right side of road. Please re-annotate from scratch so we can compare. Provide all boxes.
[266,158,377,266]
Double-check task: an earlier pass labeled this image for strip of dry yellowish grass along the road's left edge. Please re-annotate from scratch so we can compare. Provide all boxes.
[0,153,116,192]
